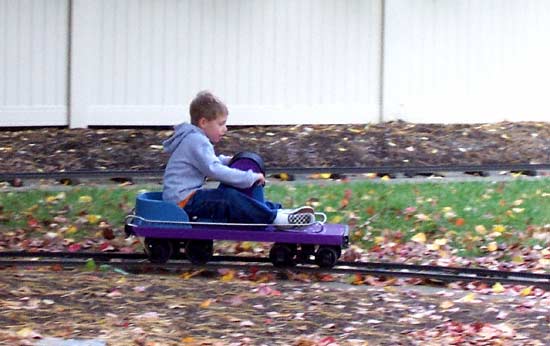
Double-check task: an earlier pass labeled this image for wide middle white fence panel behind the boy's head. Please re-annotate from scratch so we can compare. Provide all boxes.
[71,0,380,126]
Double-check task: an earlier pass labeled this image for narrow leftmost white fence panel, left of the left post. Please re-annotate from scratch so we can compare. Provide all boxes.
[0,0,68,126]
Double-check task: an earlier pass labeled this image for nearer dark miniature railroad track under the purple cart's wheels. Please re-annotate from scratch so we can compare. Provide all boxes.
[0,252,550,290]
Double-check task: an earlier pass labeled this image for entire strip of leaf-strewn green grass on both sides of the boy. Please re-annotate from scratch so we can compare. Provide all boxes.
[0,179,550,255]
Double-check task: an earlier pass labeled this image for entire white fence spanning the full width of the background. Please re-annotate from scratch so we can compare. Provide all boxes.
[0,0,550,127]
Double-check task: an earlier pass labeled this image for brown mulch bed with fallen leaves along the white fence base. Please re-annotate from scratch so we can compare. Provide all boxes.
[0,121,550,173]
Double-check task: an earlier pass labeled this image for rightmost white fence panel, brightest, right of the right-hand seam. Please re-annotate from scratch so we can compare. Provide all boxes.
[384,0,550,123]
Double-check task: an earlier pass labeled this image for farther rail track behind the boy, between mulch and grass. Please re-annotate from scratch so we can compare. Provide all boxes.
[0,163,550,181]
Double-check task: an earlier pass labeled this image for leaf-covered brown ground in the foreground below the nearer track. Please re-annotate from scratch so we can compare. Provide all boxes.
[0,268,550,346]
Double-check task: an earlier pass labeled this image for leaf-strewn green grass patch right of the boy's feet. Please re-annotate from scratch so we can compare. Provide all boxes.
[268,179,550,256]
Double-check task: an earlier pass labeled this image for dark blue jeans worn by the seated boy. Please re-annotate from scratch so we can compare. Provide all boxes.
[183,184,281,224]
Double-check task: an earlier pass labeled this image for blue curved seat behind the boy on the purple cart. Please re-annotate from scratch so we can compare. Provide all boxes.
[135,191,190,228]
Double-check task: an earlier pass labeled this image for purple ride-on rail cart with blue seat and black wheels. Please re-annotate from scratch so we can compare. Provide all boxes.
[125,152,349,268]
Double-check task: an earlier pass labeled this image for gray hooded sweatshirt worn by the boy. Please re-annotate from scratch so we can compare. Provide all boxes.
[162,123,260,203]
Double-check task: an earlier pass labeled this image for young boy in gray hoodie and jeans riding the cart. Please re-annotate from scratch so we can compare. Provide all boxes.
[162,91,315,224]
